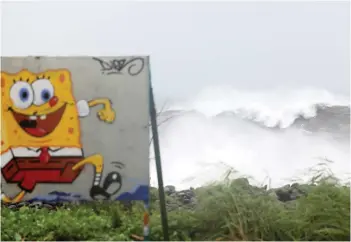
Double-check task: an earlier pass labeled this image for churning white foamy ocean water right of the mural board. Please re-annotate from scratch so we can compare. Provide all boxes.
[150,87,350,189]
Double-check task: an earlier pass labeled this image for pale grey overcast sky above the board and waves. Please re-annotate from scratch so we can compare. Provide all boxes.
[1,1,350,102]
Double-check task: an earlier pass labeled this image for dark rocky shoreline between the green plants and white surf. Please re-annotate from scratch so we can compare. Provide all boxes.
[2,178,313,211]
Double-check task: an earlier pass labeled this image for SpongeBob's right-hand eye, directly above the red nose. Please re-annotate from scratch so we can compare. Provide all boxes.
[32,79,54,105]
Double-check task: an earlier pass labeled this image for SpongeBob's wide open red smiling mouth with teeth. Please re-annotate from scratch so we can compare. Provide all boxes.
[11,104,66,137]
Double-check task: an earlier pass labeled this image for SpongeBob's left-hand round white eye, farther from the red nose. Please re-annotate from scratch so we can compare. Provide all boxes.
[10,81,33,109]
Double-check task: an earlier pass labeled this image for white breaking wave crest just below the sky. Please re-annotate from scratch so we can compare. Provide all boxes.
[161,88,350,129]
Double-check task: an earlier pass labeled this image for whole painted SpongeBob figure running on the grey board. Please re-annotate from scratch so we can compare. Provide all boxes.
[1,69,120,203]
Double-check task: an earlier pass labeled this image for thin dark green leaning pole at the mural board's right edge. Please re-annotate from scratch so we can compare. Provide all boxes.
[150,67,169,241]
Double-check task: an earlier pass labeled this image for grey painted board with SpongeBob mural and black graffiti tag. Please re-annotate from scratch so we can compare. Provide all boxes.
[1,57,149,203]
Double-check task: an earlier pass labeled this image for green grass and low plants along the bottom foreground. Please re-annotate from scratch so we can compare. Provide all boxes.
[1,174,350,241]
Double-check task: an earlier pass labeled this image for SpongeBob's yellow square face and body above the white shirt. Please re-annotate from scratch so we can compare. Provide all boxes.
[1,69,82,153]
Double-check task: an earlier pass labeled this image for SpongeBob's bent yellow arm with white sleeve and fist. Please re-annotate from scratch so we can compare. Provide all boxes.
[77,98,115,123]
